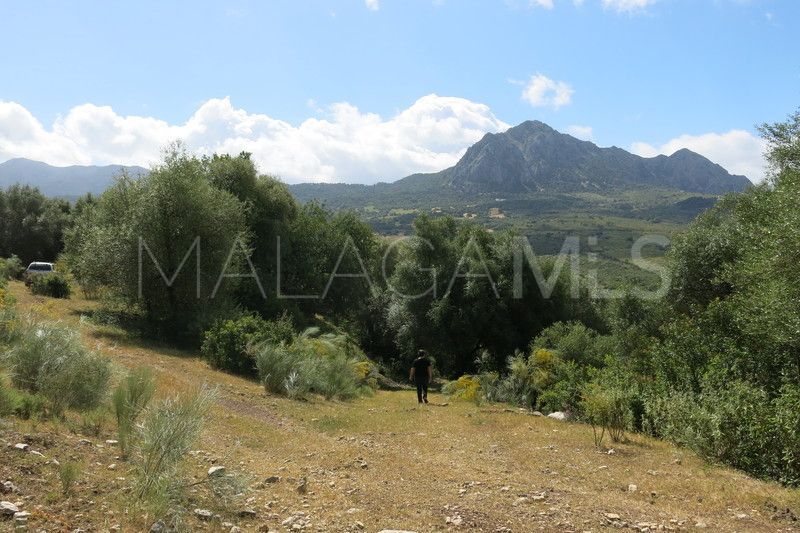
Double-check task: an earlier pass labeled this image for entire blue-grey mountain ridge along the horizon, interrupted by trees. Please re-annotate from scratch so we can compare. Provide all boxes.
[0,120,751,201]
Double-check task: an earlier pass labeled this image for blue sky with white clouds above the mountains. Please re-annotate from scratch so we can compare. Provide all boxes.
[0,0,800,183]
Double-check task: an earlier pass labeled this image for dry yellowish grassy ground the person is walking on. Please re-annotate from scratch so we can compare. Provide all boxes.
[0,283,800,532]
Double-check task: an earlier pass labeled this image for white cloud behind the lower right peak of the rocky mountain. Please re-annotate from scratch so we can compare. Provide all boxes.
[631,130,766,183]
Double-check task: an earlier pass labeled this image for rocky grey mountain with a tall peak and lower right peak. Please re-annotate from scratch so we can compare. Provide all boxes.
[406,121,750,194]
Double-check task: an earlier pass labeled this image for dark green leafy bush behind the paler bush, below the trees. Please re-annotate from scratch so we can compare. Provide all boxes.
[200,315,294,376]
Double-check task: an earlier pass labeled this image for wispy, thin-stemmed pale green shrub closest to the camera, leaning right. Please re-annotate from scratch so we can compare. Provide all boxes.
[135,387,216,508]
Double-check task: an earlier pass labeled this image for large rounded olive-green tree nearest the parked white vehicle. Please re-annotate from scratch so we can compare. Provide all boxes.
[67,146,250,342]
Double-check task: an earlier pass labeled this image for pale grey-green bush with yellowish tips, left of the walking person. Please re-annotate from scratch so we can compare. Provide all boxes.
[251,328,369,400]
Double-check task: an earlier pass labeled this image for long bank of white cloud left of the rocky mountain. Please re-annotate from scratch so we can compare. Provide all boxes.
[0,94,509,183]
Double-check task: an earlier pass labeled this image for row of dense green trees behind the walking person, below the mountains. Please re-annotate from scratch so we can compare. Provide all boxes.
[40,148,596,375]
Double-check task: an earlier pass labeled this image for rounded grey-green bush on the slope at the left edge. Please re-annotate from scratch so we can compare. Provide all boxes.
[5,322,111,414]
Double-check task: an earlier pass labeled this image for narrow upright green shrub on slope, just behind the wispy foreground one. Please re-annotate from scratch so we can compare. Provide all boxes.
[111,367,156,458]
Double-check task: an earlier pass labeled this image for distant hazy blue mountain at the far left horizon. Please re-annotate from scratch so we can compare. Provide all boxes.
[0,158,147,197]
